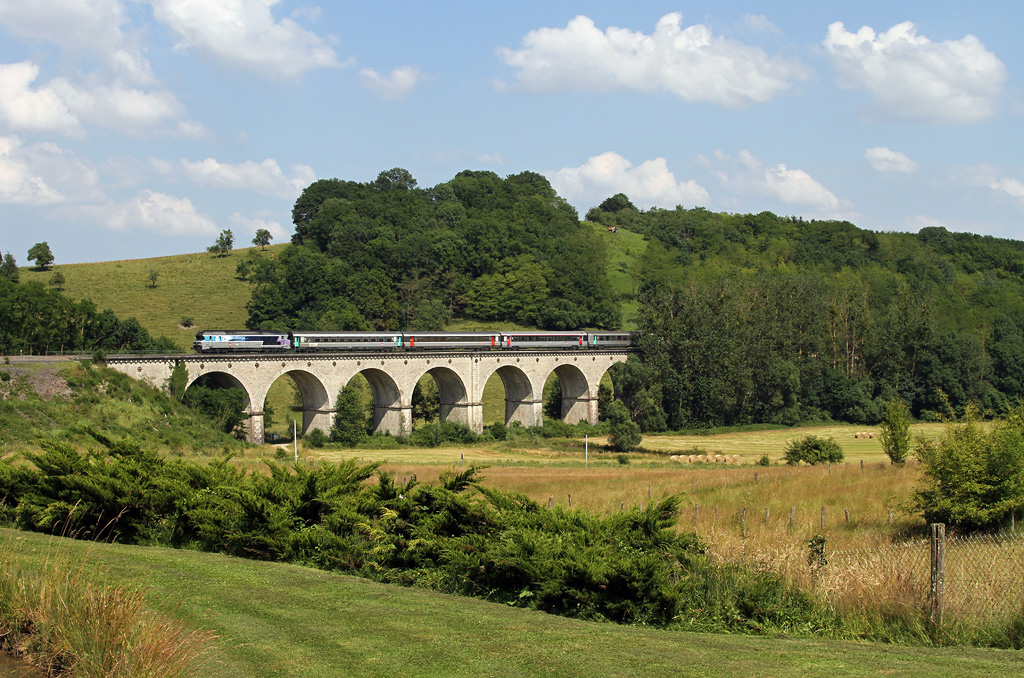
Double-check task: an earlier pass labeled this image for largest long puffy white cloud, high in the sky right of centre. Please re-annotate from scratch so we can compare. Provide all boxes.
[498,12,807,109]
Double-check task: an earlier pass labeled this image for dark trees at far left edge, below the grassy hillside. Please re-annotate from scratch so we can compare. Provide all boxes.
[0,276,179,355]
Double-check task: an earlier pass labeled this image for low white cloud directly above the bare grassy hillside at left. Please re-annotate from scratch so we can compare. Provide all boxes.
[75,190,217,236]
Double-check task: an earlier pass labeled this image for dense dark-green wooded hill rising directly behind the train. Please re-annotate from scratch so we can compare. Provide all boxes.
[240,169,621,330]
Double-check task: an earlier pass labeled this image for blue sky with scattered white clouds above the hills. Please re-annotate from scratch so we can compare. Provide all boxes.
[0,0,1024,265]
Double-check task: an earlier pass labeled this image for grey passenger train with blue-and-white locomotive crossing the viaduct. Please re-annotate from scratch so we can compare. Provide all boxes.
[193,330,633,353]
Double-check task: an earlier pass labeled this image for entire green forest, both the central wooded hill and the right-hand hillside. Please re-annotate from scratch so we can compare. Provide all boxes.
[251,173,1024,431]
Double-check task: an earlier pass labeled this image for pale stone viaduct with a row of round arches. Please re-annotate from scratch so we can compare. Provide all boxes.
[106,350,629,443]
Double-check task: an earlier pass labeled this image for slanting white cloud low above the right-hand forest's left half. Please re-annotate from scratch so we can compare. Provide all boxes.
[713,150,850,214]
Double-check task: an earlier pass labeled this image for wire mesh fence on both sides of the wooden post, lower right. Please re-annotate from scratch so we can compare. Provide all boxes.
[816,534,1024,624]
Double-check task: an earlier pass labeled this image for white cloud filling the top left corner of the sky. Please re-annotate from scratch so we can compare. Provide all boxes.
[0,0,156,84]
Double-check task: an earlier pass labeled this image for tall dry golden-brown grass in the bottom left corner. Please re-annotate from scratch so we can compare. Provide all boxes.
[0,536,214,678]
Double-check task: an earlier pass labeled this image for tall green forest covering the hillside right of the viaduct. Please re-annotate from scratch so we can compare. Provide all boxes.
[588,196,1024,430]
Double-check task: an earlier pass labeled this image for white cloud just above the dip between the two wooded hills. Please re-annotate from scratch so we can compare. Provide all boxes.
[547,151,710,208]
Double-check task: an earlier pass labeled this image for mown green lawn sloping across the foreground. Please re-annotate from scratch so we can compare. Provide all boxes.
[0,529,1024,678]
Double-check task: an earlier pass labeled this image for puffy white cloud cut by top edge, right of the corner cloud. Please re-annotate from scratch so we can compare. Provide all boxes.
[153,0,342,79]
